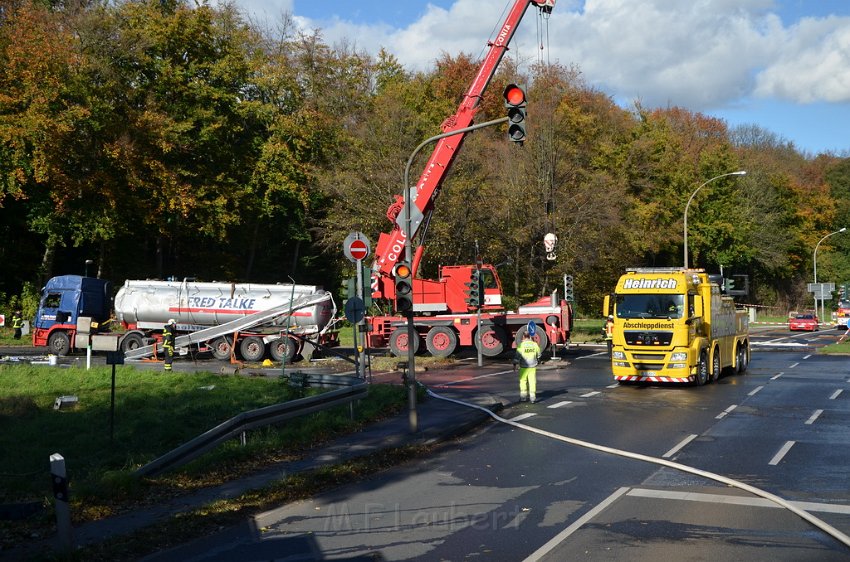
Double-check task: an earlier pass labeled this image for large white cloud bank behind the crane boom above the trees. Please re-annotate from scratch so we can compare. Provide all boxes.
[240,0,850,111]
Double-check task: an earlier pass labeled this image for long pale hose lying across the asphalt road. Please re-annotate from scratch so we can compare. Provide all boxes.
[428,383,850,547]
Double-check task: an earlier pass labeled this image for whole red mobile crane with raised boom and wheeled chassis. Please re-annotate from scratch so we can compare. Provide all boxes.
[368,0,572,357]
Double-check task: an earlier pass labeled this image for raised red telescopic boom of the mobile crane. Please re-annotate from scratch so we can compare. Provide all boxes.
[372,0,555,284]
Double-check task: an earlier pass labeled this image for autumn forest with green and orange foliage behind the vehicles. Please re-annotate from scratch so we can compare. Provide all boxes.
[0,0,850,315]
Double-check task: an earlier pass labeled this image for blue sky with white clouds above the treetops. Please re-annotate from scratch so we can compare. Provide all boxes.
[225,0,850,156]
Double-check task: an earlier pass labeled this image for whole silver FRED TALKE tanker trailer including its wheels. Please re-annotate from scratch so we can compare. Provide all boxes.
[114,280,336,361]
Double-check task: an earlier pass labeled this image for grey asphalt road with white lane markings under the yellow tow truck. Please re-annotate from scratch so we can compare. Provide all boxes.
[134,324,850,561]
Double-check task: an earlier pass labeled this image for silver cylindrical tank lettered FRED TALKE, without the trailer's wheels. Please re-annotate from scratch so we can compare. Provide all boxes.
[114,280,334,332]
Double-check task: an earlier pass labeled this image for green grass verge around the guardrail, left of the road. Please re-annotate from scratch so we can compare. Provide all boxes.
[0,365,406,550]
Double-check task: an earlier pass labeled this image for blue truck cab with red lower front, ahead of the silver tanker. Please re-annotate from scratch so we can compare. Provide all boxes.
[32,275,112,355]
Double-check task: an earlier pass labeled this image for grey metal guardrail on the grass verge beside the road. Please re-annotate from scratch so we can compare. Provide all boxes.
[135,374,369,476]
